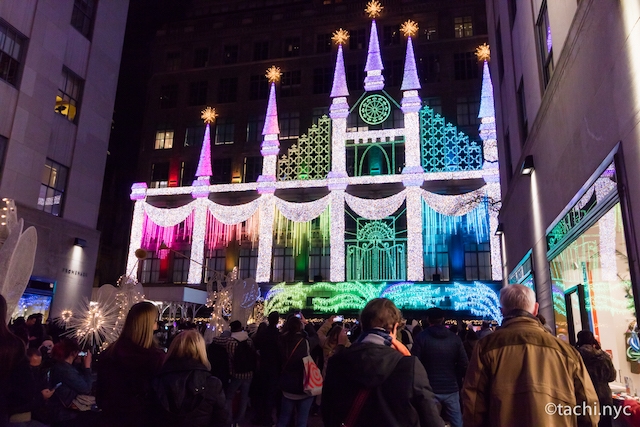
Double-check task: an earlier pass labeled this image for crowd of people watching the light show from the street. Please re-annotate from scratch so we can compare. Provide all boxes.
[0,285,628,427]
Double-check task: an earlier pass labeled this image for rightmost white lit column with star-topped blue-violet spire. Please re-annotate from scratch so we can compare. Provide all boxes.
[476,43,503,280]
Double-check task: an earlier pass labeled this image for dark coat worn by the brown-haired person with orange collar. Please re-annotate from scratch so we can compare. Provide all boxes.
[321,342,444,427]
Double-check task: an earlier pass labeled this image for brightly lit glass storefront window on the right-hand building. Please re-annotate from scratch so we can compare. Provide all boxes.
[550,202,640,393]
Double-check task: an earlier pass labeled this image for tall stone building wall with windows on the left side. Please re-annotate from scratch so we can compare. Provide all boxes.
[0,0,129,315]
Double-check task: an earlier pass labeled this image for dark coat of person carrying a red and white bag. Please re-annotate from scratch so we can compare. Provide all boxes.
[279,325,318,396]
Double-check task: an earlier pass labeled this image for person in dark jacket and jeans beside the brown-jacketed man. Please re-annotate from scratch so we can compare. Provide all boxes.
[411,307,469,427]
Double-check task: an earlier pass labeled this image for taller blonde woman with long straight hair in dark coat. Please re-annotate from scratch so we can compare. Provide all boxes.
[96,301,164,427]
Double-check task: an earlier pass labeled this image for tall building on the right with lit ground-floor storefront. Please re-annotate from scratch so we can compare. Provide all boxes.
[487,0,640,386]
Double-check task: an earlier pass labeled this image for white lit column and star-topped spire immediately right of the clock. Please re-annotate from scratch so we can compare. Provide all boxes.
[400,20,424,281]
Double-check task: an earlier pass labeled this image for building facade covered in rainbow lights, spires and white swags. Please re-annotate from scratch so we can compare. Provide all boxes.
[126,2,502,320]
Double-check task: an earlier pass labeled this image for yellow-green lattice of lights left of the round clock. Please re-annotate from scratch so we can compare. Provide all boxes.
[278,116,331,181]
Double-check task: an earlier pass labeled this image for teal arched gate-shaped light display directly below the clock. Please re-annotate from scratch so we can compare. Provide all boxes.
[345,217,407,281]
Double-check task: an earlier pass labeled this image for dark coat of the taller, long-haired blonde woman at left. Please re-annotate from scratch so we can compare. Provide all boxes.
[96,338,164,427]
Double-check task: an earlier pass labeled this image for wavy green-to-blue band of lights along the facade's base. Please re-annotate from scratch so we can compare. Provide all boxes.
[264,281,502,322]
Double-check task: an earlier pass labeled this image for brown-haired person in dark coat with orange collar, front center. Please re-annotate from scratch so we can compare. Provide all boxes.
[322,298,444,427]
